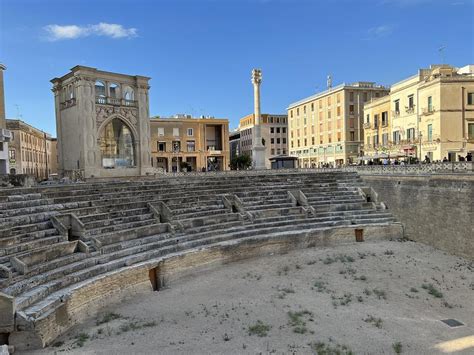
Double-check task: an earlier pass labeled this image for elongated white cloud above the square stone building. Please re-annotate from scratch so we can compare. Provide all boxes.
[44,22,137,41]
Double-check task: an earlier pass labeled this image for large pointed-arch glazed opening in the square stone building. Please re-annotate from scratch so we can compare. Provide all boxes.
[100,118,135,169]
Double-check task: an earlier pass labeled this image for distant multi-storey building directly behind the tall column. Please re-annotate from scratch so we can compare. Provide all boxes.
[239,113,288,169]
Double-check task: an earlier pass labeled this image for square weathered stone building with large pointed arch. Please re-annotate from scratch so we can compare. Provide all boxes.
[51,65,152,178]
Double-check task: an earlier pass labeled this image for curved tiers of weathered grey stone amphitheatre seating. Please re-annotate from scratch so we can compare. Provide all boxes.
[0,172,399,345]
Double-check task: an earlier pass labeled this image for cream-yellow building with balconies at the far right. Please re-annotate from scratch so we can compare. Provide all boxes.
[364,64,474,161]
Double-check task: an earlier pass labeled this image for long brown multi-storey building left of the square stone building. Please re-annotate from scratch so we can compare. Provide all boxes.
[6,119,57,180]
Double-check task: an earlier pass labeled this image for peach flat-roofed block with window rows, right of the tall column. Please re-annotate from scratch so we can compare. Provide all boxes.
[287,82,389,168]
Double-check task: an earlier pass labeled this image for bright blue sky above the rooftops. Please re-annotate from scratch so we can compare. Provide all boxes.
[0,0,474,134]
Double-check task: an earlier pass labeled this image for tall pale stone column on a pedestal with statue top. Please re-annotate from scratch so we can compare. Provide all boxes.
[252,69,268,170]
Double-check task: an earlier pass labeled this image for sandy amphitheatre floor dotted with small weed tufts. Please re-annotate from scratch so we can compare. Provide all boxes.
[22,241,474,354]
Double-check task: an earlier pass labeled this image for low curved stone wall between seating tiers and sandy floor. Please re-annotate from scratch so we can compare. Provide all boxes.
[7,223,403,350]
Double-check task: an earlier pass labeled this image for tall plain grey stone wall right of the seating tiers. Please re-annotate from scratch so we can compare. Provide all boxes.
[362,175,474,259]
